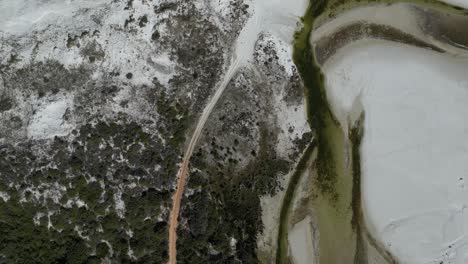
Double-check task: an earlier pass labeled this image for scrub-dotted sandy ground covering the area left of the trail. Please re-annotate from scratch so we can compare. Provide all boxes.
[0,0,252,263]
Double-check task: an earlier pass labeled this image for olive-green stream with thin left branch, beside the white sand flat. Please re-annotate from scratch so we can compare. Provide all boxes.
[276,0,468,264]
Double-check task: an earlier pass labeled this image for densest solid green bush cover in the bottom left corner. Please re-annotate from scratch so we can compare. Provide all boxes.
[0,195,96,263]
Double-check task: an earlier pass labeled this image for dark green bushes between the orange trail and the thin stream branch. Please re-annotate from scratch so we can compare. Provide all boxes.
[177,128,291,263]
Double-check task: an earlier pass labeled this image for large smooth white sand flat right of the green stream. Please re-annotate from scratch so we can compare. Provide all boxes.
[324,40,468,263]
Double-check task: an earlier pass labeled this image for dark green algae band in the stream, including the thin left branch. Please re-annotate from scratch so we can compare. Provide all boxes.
[276,0,337,263]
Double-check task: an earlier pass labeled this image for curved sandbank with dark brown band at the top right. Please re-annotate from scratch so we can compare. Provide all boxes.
[310,1,468,65]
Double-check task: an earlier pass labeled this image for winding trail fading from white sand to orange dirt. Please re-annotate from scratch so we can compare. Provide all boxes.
[169,0,307,264]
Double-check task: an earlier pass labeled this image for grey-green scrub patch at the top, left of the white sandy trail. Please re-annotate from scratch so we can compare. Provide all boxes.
[151,0,247,113]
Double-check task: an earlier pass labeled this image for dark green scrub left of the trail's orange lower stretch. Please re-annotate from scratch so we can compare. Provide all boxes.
[0,43,191,263]
